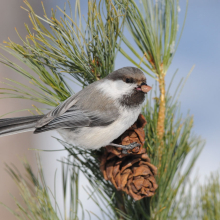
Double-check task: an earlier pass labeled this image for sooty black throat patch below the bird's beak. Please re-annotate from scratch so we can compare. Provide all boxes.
[120,90,145,107]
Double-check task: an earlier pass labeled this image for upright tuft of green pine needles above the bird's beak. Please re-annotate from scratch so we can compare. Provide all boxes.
[115,0,188,76]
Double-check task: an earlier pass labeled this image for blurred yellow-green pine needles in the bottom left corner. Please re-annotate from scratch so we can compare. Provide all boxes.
[0,158,60,220]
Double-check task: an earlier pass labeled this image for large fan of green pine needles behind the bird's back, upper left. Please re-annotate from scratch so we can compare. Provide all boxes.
[0,0,124,110]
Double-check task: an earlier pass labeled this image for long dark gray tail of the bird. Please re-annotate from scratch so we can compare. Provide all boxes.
[0,115,44,137]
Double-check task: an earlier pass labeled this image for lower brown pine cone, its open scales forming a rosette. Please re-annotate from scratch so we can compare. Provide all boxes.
[100,150,158,200]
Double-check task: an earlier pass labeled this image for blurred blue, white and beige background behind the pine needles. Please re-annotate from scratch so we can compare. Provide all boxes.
[0,0,220,220]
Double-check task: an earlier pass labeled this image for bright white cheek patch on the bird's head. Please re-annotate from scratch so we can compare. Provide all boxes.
[97,79,135,99]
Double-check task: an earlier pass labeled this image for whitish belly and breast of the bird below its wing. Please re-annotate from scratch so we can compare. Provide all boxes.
[58,106,141,149]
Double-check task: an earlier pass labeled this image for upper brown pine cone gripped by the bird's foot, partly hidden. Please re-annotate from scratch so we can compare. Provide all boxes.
[106,114,147,157]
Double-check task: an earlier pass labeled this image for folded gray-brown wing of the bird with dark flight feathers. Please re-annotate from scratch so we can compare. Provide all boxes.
[35,83,119,133]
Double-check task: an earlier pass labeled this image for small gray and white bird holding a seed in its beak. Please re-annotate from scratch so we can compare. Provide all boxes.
[0,67,151,152]
